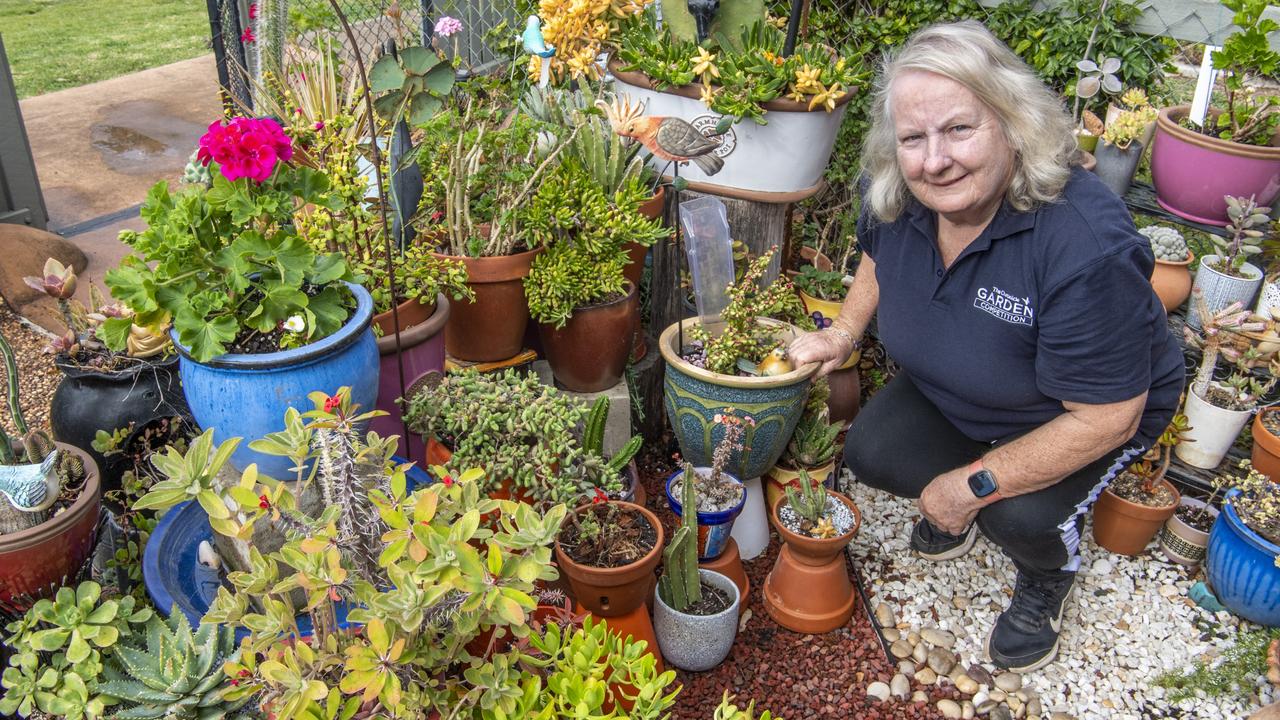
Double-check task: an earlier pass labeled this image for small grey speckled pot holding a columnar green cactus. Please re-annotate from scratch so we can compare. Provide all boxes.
[653,570,742,671]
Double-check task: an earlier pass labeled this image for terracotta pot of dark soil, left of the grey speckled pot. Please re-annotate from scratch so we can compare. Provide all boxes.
[556,502,664,618]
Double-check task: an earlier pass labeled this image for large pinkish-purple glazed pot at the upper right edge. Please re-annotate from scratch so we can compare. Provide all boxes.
[1151,105,1280,225]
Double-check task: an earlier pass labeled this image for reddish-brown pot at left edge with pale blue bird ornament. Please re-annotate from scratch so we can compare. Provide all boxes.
[0,442,102,614]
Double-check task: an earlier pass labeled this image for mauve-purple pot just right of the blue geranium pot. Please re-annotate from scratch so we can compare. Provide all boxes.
[369,293,449,466]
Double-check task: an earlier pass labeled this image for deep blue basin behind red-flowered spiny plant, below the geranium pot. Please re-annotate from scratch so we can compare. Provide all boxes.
[142,457,435,634]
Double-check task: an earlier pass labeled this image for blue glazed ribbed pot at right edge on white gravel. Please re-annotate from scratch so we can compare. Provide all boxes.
[1204,489,1280,628]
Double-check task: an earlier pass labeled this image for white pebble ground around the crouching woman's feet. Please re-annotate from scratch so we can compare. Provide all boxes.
[845,470,1280,720]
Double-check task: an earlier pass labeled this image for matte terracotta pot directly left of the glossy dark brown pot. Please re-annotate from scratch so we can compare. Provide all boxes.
[433,247,543,363]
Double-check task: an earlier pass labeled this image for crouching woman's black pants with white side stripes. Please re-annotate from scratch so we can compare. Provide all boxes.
[845,373,1143,573]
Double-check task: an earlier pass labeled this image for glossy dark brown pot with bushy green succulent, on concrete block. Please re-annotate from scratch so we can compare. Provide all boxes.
[538,282,640,392]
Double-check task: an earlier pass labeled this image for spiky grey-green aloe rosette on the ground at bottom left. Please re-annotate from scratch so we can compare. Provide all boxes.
[100,611,250,720]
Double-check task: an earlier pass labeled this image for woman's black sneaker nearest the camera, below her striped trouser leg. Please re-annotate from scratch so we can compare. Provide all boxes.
[987,570,1075,673]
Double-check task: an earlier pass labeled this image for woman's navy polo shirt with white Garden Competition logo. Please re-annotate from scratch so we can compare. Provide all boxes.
[858,168,1185,447]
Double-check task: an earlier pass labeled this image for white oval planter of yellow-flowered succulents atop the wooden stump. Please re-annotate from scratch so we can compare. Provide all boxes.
[611,64,856,202]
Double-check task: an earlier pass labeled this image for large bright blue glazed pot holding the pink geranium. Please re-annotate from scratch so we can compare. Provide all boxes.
[172,283,378,479]
